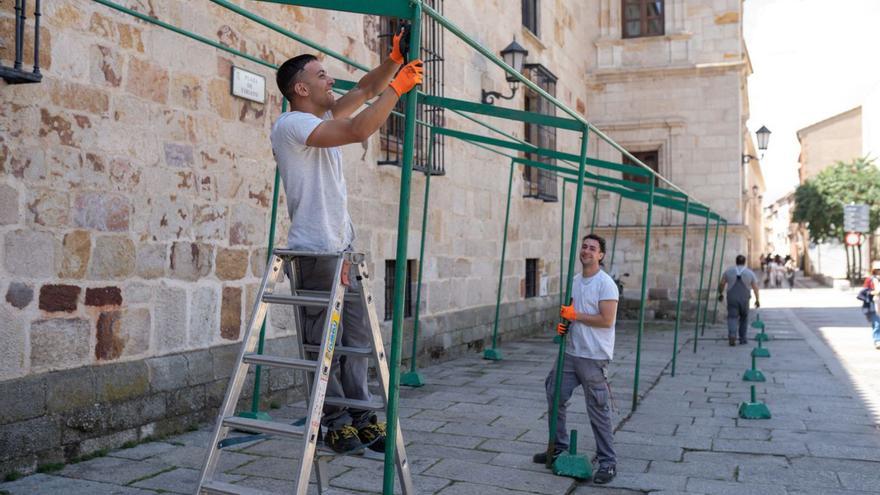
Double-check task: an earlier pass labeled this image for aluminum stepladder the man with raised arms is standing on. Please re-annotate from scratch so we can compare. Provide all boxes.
[196,249,415,495]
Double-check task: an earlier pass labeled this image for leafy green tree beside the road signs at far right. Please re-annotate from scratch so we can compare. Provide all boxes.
[792,157,880,242]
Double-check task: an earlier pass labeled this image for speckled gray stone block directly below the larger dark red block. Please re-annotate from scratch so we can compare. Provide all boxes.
[31,318,91,371]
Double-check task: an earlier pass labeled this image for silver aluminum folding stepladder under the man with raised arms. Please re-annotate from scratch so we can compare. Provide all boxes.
[196,249,415,495]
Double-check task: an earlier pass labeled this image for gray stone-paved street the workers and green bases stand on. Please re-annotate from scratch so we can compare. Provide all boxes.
[0,288,880,495]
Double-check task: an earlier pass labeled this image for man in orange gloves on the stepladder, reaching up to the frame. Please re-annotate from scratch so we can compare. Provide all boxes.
[271,31,423,452]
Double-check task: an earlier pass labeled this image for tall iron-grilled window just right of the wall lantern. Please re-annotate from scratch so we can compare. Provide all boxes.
[523,64,557,202]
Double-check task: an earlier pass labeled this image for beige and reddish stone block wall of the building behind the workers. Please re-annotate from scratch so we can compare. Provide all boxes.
[0,0,743,476]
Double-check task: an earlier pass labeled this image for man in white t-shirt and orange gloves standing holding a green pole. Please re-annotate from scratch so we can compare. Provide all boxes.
[532,234,619,485]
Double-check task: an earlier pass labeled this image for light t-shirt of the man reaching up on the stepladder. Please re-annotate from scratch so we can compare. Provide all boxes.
[270,111,355,252]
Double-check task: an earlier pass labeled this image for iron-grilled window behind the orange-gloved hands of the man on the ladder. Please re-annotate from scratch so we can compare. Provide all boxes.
[379,0,446,175]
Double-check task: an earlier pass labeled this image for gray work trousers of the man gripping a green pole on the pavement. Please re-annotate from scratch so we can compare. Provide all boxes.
[544,354,617,467]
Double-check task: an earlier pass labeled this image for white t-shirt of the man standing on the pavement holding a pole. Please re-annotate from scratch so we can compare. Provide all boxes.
[565,270,620,361]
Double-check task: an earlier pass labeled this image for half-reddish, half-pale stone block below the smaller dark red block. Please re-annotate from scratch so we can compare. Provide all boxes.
[95,308,151,361]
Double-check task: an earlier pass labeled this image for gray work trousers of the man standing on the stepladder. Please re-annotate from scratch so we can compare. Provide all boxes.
[299,258,372,430]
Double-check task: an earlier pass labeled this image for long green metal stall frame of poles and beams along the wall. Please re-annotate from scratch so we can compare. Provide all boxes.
[93,0,727,495]
